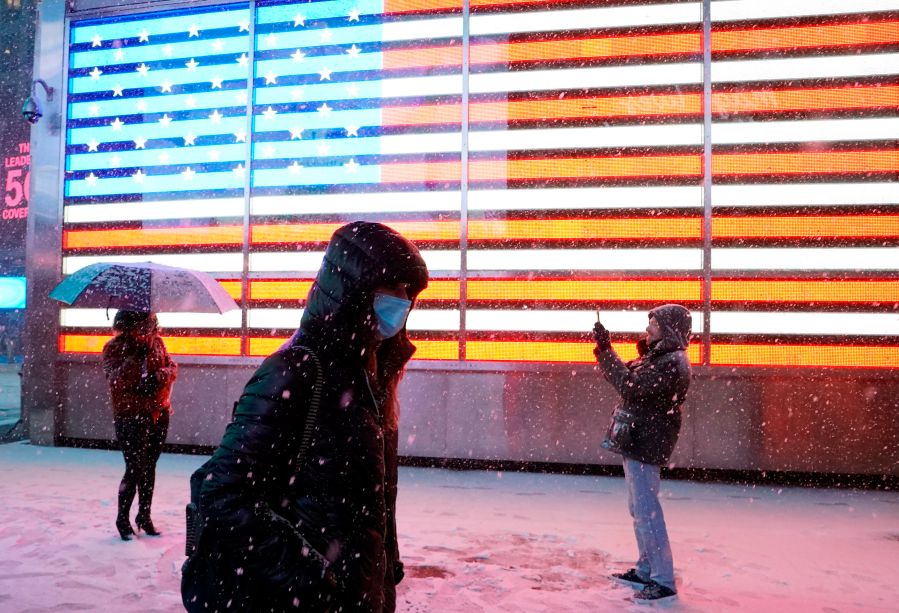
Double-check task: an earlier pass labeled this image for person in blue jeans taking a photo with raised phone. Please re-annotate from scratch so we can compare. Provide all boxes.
[593,304,692,603]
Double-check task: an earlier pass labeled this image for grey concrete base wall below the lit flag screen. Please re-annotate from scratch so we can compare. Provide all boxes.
[56,359,899,475]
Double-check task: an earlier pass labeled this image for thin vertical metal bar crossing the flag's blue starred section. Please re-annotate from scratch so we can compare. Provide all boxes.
[240,1,256,356]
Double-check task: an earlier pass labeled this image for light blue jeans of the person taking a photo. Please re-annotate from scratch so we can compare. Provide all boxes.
[624,458,676,590]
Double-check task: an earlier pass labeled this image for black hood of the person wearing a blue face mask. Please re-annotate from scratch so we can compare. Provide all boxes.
[295,221,428,355]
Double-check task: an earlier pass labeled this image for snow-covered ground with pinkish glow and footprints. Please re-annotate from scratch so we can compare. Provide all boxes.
[0,443,899,613]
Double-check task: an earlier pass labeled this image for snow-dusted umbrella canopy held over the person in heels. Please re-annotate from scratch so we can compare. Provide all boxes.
[50,262,240,313]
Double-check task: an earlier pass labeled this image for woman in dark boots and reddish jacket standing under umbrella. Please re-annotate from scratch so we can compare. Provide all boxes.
[103,310,178,541]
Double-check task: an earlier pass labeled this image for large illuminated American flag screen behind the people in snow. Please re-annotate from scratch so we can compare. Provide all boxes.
[60,0,899,368]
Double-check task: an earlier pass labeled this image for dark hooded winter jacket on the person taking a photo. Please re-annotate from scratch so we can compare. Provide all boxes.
[596,304,691,465]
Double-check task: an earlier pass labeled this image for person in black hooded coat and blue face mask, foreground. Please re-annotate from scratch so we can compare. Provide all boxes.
[182,222,428,613]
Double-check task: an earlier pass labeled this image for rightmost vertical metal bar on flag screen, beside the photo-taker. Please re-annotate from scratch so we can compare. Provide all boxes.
[702,0,712,365]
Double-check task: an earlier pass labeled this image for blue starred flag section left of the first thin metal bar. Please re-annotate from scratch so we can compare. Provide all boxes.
[65,4,251,203]
